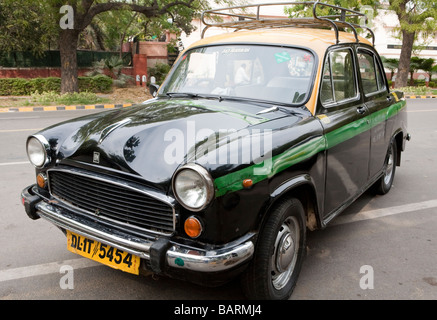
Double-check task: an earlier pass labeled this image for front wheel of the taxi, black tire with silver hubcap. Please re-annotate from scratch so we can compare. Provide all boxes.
[238,198,306,300]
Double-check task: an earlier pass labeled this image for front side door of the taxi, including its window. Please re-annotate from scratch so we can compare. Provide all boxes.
[317,46,370,217]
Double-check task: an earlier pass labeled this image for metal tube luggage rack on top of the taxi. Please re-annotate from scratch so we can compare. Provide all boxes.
[201,1,375,45]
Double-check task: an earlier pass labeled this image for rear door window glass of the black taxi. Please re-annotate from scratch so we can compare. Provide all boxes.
[358,51,386,95]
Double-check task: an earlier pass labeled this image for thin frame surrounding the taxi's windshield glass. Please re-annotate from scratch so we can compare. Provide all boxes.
[157,42,319,107]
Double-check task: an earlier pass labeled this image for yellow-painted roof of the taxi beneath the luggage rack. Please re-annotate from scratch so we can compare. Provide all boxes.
[188,27,372,58]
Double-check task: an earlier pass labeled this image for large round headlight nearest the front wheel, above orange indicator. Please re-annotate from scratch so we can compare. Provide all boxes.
[173,164,214,211]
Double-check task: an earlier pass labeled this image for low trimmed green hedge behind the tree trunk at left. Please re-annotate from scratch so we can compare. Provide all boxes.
[0,75,112,96]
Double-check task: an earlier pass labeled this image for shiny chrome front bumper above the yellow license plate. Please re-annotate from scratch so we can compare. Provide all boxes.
[27,188,254,273]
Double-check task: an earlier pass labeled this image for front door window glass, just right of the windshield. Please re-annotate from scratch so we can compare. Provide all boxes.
[320,49,357,104]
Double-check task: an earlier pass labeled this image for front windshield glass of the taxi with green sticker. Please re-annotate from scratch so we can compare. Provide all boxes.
[159,45,315,105]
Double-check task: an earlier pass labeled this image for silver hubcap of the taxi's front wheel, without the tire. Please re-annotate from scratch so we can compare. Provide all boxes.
[272,217,300,290]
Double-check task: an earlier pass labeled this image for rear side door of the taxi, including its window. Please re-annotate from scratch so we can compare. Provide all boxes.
[357,47,393,179]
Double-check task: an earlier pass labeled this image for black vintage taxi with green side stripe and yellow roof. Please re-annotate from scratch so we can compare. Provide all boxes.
[22,4,409,299]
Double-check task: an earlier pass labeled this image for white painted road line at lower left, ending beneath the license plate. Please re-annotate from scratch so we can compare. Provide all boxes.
[0,258,102,282]
